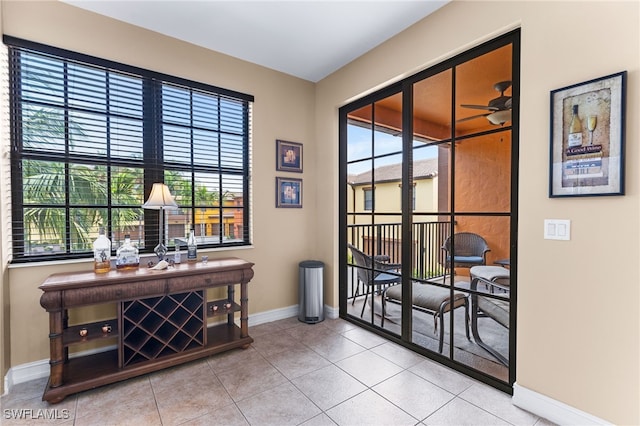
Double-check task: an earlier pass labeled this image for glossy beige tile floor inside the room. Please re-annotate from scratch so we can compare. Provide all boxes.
[0,318,551,426]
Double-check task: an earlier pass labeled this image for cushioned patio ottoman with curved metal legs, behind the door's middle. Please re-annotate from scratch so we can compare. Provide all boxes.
[381,281,471,353]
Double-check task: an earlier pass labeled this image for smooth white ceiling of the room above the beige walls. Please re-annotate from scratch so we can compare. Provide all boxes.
[62,0,449,82]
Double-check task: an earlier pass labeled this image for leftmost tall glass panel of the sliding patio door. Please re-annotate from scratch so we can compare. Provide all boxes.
[346,94,402,334]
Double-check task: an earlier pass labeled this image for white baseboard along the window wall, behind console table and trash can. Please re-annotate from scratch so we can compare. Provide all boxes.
[4,305,339,395]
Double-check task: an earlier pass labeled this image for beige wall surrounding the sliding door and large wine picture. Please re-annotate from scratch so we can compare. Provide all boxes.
[316,1,640,424]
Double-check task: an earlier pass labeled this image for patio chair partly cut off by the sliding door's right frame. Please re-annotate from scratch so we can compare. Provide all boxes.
[469,266,510,367]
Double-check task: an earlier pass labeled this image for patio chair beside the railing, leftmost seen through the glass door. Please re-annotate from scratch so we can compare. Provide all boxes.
[348,244,402,318]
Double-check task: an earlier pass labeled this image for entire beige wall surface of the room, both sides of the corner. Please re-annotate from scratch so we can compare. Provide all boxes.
[0,0,640,424]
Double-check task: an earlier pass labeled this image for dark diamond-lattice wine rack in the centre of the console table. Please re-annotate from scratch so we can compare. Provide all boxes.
[120,291,206,367]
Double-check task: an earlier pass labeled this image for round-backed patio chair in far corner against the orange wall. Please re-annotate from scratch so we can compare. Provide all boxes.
[442,232,491,274]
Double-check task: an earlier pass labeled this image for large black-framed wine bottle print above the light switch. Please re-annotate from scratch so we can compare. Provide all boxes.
[549,71,627,198]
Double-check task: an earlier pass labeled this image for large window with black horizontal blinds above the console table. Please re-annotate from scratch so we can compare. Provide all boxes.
[4,36,253,262]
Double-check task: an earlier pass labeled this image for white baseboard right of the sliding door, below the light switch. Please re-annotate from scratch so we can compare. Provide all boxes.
[511,383,611,426]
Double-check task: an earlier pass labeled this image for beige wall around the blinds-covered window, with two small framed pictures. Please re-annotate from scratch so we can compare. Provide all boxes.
[1,1,317,386]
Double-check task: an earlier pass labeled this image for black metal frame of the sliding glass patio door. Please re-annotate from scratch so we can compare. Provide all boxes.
[338,29,521,394]
